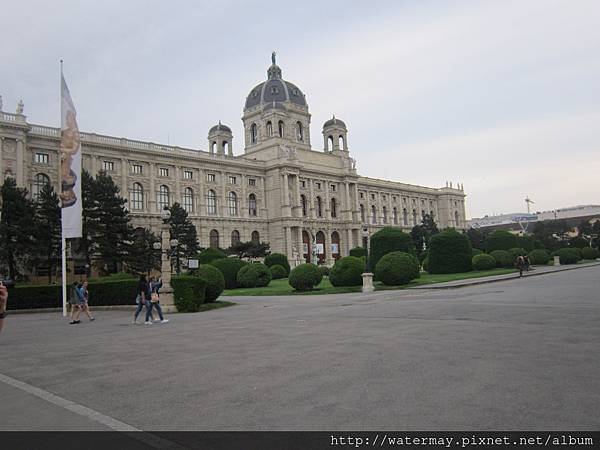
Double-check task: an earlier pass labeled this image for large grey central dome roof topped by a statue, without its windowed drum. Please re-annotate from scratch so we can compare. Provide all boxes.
[245,54,307,108]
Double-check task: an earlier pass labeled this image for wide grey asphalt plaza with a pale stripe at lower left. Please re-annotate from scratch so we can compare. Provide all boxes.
[0,266,600,430]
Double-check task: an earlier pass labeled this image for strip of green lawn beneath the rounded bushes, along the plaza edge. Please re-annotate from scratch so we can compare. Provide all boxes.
[221,269,516,296]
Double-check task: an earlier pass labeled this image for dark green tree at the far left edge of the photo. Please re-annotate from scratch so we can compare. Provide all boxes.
[0,178,35,280]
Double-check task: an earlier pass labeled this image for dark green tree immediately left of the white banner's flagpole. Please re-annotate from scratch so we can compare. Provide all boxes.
[35,184,61,284]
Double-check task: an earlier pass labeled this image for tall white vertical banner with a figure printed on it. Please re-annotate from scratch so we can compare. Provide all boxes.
[60,73,82,239]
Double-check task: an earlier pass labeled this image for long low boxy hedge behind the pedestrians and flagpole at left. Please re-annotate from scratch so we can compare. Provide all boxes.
[8,277,138,310]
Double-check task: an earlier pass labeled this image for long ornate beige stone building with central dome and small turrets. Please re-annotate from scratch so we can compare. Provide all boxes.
[0,57,466,264]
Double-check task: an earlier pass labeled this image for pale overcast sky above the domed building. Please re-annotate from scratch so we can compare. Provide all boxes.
[0,0,600,217]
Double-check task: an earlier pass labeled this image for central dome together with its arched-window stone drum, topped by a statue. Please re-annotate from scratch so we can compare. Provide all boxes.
[242,52,310,153]
